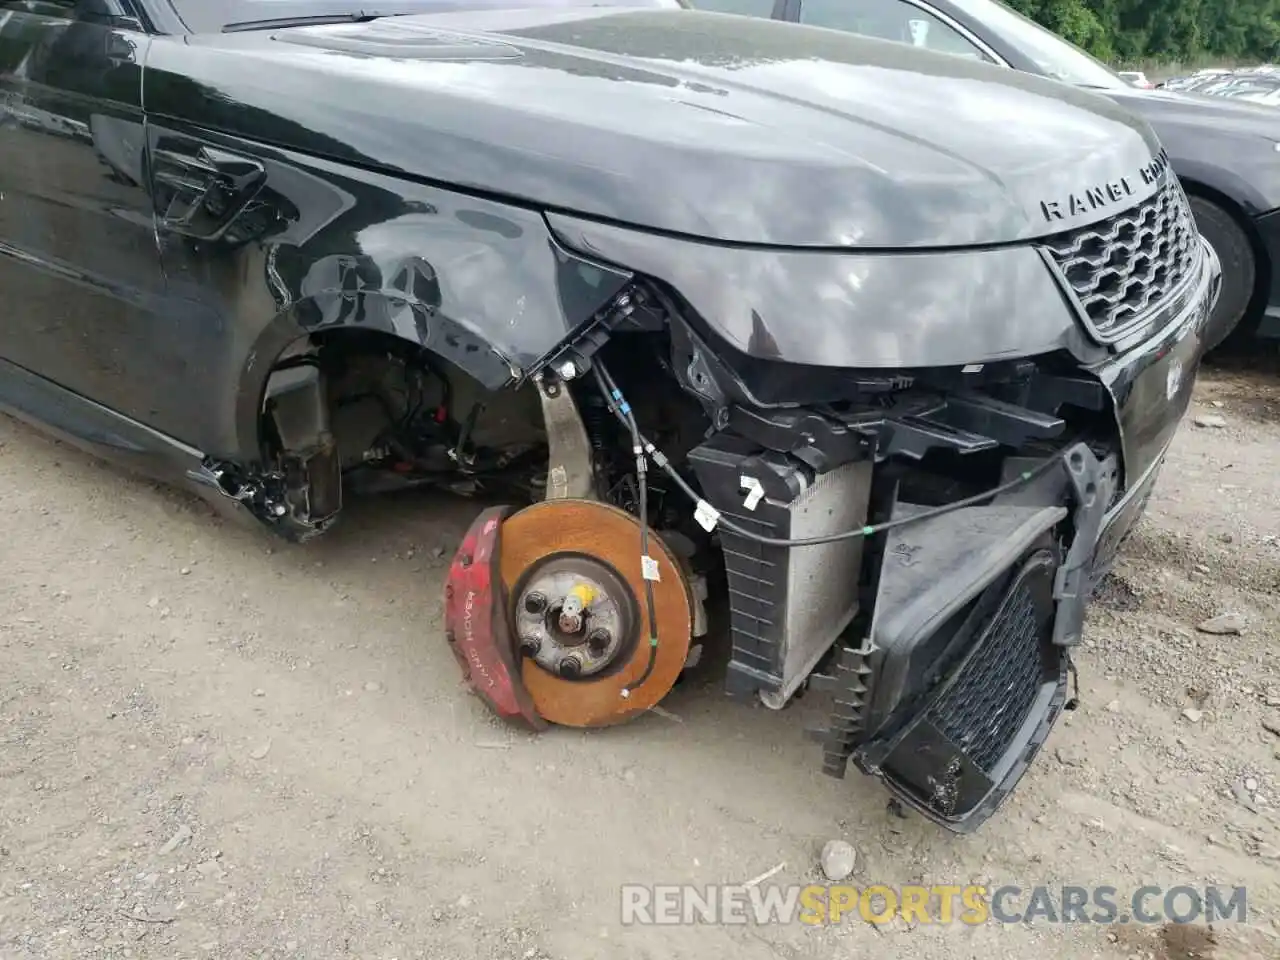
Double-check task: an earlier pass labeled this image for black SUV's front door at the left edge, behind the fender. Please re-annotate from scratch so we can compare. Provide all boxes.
[0,0,187,433]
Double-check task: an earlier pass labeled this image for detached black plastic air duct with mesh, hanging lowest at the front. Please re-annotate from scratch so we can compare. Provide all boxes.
[813,444,1116,833]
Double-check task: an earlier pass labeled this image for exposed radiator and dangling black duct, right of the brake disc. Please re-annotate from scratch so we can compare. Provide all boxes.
[586,330,1125,831]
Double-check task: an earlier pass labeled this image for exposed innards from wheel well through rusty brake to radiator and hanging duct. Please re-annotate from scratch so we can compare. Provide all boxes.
[217,267,1218,831]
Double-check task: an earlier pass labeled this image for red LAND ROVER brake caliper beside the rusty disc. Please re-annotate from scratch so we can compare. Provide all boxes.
[444,507,548,731]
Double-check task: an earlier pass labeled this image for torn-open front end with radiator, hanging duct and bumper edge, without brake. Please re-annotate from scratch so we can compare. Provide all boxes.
[463,175,1220,832]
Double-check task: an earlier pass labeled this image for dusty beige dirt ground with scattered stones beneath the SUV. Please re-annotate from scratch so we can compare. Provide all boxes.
[0,353,1280,960]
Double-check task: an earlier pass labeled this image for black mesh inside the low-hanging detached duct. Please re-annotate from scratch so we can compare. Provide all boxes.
[929,581,1043,772]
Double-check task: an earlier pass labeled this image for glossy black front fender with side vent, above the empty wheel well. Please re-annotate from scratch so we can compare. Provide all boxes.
[147,119,631,466]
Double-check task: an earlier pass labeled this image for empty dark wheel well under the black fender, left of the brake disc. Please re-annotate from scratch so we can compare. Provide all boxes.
[259,328,547,530]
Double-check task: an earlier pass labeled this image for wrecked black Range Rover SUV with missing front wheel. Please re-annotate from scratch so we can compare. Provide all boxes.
[0,0,1220,831]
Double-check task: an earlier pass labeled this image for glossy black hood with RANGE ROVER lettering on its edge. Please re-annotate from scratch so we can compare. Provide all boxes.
[147,9,1160,248]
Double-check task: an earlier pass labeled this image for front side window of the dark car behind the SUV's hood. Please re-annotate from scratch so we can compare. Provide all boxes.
[797,0,1001,63]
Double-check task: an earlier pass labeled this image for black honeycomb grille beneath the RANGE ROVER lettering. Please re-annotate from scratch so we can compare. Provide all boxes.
[1044,175,1199,339]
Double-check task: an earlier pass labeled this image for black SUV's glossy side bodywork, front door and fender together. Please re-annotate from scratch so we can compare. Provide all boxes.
[0,10,628,485]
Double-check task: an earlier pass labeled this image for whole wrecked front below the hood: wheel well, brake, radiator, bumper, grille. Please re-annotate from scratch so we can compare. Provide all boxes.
[206,150,1220,832]
